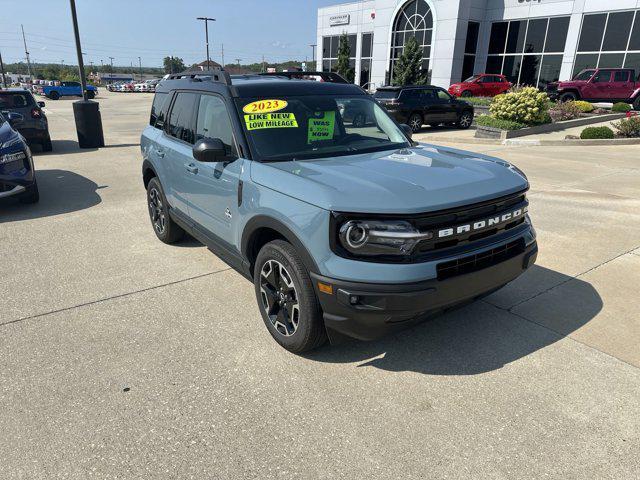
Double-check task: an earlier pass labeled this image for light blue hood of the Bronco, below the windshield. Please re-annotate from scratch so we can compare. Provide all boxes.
[251,145,529,213]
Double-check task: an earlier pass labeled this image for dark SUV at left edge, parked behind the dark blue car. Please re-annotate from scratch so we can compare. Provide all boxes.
[0,88,53,152]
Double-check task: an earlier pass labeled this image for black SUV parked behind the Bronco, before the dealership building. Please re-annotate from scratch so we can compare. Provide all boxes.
[374,86,474,132]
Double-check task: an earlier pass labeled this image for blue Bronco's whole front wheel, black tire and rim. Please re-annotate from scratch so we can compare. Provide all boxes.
[253,240,327,353]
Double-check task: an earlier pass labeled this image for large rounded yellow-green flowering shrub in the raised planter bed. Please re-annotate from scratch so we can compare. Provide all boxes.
[490,87,549,125]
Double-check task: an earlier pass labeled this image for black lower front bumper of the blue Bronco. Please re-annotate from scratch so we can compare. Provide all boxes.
[311,241,538,340]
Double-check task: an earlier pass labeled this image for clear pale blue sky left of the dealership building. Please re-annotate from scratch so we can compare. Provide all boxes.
[0,0,340,67]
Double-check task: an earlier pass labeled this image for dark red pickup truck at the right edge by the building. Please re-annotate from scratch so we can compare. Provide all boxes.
[547,68,640,110]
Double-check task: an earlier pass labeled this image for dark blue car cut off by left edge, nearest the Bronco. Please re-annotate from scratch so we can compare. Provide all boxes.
[0,112,40,203]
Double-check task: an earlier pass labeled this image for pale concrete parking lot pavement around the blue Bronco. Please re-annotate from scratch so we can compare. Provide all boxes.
[0,90,640,479]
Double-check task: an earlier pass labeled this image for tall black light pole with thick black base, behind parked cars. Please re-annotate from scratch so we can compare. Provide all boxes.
[69,0,104,148]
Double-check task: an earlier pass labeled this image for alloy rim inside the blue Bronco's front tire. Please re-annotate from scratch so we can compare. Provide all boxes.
[260,260,300,337]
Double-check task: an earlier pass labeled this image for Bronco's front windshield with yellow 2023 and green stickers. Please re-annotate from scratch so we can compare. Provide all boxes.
[237,95,409,161]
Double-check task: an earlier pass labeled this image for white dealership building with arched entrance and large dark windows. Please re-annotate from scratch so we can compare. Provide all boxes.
[316,0,640,89]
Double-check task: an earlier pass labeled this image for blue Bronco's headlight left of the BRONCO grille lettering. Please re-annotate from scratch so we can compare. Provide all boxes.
[338,220,433,256]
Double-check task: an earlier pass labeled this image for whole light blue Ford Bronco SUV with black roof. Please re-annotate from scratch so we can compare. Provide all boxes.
[141,70,537,352]
